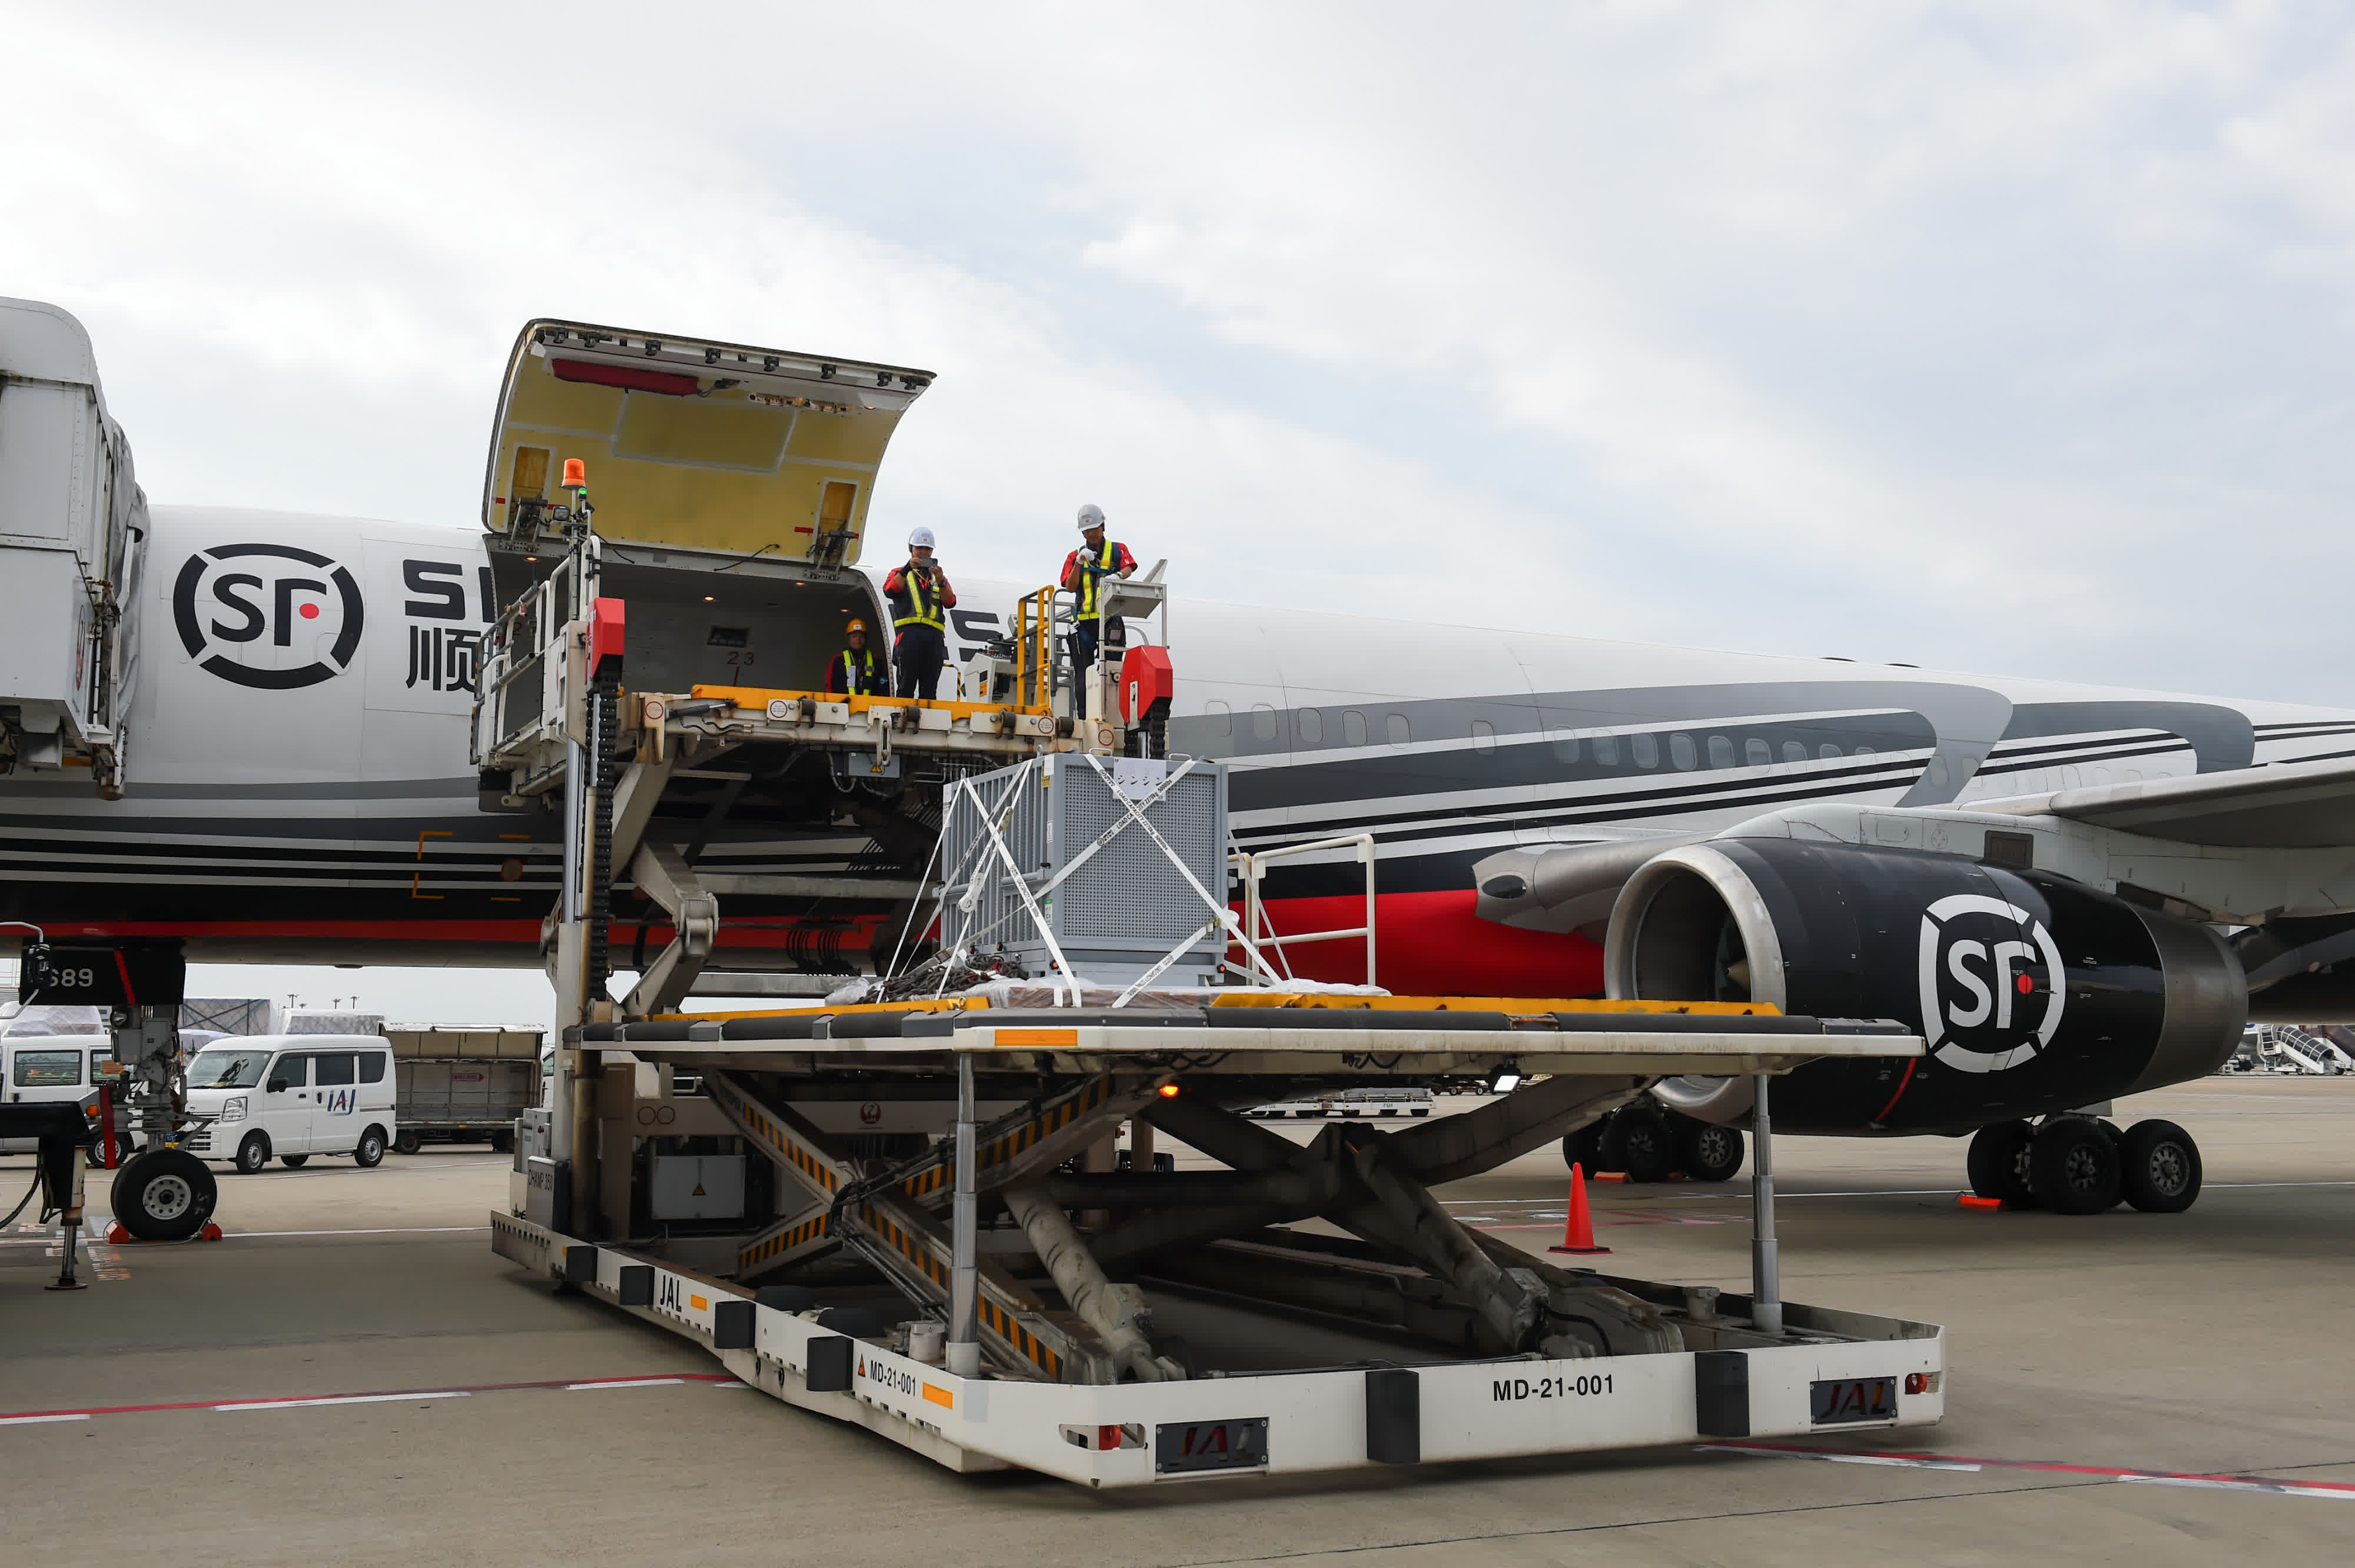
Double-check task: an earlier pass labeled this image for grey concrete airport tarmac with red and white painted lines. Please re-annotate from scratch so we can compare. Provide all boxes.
[0,1078,2355,1568]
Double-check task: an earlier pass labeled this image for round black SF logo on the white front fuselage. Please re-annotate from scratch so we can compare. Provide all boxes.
[172,544,365,692]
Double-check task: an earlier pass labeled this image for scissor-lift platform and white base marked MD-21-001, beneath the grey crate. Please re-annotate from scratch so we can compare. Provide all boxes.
[492,993,1943,1486]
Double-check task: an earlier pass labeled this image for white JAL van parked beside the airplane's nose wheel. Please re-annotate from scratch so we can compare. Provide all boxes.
[181,1033,393,1175]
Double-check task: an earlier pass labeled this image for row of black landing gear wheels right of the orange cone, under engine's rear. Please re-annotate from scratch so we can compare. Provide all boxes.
[1969,1116,2200,1215]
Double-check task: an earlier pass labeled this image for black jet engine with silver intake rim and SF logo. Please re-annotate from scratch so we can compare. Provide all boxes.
[1604,838,2249,1132]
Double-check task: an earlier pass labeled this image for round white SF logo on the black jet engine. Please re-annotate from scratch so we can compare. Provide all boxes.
[1922,892,2068,1073]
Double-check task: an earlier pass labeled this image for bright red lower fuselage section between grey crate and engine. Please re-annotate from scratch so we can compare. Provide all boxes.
[1236,887,1604,996]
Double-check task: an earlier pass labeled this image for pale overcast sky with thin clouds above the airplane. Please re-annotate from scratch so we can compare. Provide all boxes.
[0,0,2355,1012]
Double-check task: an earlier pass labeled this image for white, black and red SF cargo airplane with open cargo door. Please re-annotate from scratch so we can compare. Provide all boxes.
[0,301,2355,1210]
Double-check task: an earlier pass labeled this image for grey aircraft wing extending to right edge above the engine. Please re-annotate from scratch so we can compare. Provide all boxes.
[1966,758,2355,850]
